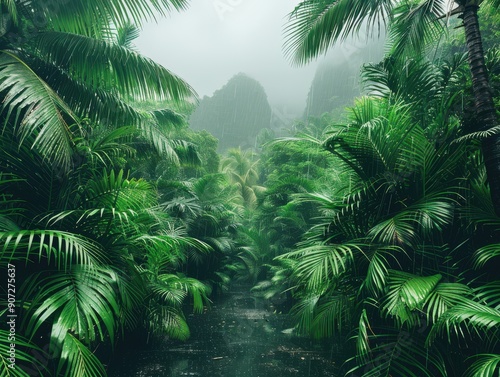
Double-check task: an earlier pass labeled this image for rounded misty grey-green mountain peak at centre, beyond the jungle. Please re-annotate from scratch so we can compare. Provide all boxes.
[189,73,271,151]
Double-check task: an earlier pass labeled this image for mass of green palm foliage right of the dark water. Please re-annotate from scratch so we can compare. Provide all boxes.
[250,6,500,376]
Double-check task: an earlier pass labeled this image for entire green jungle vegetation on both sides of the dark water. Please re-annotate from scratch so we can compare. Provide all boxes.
[0,0,500,377]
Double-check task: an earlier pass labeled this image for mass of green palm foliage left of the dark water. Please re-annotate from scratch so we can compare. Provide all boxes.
[0,0,225,376]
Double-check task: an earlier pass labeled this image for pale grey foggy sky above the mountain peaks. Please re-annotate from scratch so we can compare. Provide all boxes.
[135,0,324,114]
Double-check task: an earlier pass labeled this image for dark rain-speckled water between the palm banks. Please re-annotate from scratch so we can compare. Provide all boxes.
[109,290,337,377]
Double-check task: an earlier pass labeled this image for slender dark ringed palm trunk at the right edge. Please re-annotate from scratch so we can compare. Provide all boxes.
[463,4,500,216]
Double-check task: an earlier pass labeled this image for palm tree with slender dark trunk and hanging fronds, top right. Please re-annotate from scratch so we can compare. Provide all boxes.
[285,0,500,215]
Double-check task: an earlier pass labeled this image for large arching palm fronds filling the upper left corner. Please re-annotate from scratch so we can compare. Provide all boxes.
[0,0,193,171]
